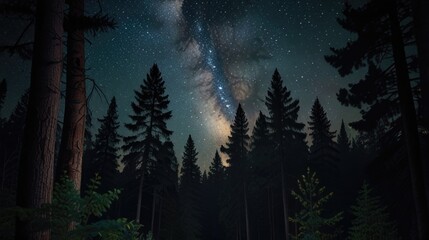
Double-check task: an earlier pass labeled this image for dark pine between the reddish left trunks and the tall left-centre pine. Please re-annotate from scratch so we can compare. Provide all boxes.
[92,97,120,191]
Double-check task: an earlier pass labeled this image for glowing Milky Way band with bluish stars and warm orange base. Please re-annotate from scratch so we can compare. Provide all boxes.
[159,0,269,145]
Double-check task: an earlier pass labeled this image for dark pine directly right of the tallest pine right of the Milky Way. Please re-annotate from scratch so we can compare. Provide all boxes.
[308,98,339,184]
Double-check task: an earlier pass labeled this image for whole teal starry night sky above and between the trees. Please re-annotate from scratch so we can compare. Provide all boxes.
[0,0,363,169]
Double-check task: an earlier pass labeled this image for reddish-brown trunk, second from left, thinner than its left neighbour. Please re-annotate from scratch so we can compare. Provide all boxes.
[58,0,86,190]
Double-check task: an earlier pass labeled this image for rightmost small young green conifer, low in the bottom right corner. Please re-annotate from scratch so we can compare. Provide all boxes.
[348,183,400,240]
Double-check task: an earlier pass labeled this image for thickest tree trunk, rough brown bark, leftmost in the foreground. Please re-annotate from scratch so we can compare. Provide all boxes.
[15,0,64,240]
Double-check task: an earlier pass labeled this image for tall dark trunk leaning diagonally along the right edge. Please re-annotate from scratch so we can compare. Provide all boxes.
[389,1,429,240]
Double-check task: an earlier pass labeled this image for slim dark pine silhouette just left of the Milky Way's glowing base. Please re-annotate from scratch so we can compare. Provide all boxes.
[179,135,202,240]
